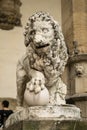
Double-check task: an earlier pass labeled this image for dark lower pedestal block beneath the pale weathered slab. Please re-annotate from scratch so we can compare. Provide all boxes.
[4,121,87,130]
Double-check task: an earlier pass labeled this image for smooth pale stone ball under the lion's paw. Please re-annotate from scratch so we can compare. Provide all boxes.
[24,87,49,106]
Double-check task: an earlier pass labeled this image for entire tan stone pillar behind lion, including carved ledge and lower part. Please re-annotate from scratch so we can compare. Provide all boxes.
[61,0,87,120]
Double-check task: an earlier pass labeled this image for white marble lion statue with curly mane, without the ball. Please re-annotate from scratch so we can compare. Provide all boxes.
[17,12,68,106]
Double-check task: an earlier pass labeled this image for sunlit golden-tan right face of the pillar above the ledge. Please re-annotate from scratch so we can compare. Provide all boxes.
[72,0,87,54]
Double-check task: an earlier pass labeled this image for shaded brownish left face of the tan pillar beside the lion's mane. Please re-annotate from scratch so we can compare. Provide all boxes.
[61,0,73,54]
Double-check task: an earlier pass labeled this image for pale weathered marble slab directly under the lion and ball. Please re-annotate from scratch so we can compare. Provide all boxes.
[5,105,80,127]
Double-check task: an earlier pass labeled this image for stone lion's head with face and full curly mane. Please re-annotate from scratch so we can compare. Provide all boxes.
[24,12,68,81]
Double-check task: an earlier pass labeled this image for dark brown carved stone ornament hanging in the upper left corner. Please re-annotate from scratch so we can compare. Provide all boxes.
[0,0,21,30]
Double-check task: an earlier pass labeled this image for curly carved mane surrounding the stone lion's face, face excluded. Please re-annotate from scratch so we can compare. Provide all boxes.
[24,12,68,86]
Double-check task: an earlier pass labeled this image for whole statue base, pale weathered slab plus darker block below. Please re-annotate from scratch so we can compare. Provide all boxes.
[4,105,83,130]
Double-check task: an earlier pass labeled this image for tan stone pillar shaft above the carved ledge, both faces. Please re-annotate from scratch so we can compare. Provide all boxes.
[61,0,87,54]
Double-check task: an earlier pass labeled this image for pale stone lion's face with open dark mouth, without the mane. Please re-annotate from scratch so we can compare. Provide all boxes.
[30,21,54,53]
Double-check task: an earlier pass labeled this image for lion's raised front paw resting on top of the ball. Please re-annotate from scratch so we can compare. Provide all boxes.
[27,78,45,93]
